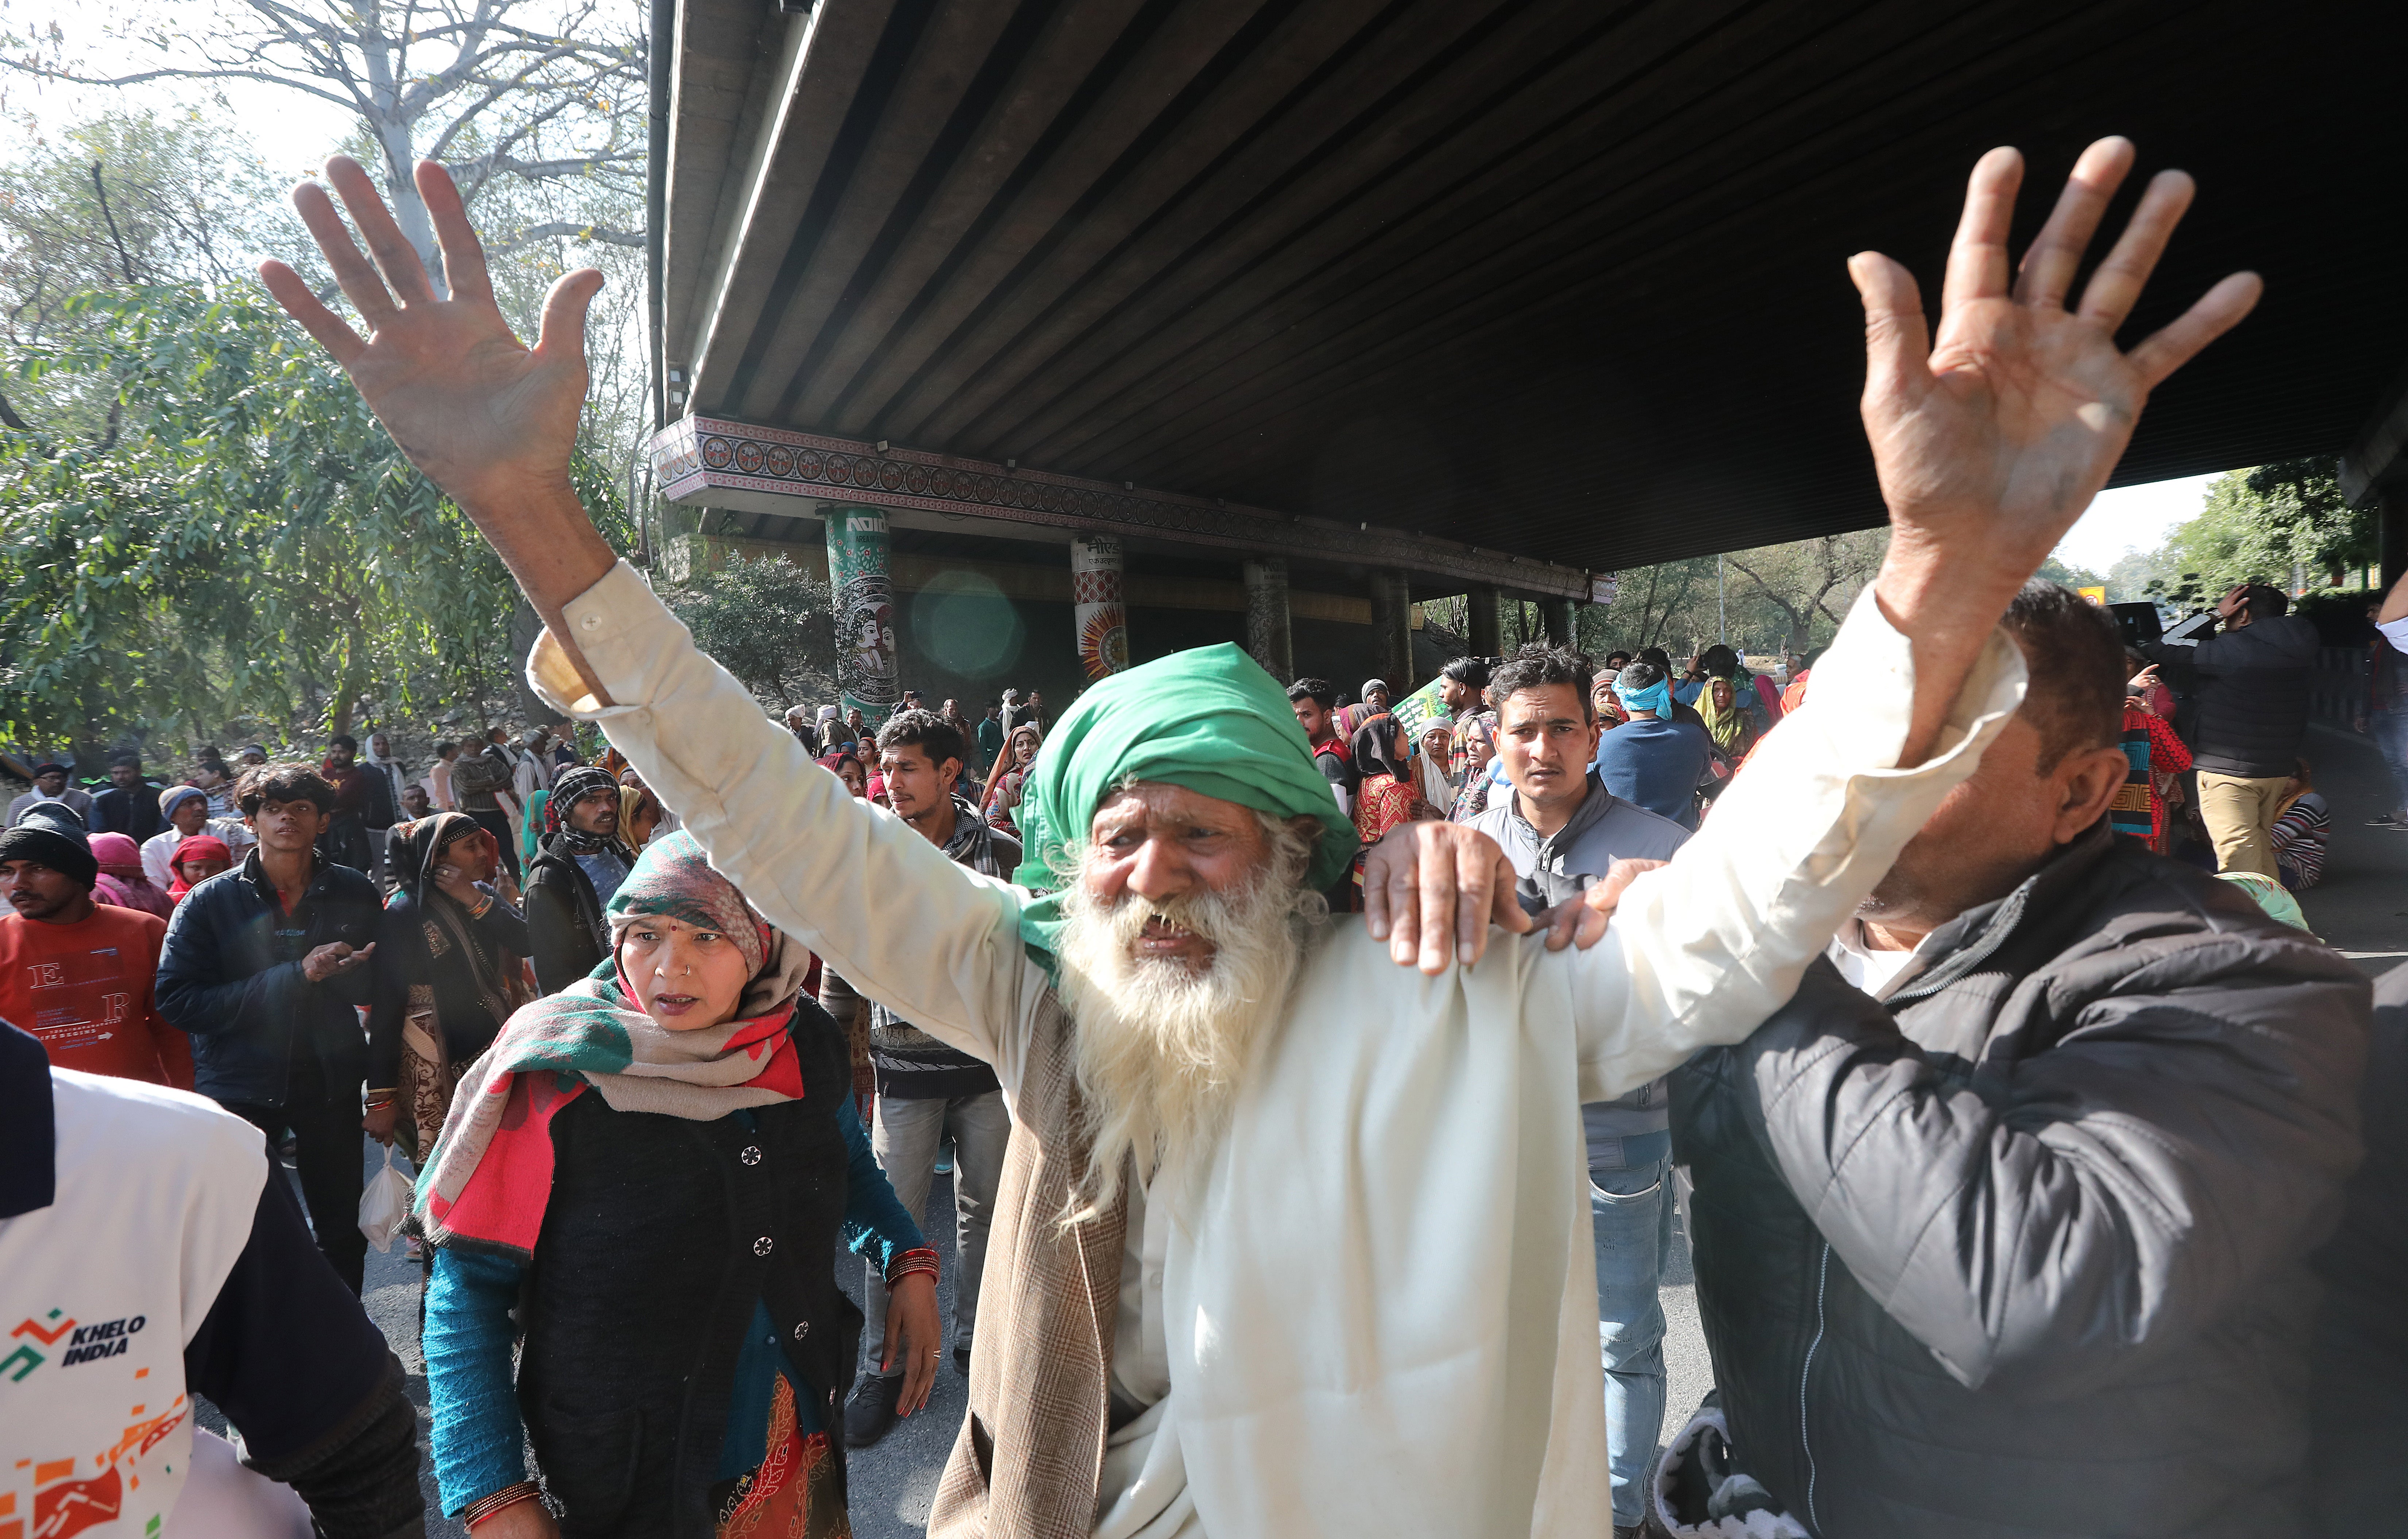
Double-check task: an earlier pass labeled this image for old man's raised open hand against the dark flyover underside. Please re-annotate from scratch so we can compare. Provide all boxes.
[1849,137,2261,587]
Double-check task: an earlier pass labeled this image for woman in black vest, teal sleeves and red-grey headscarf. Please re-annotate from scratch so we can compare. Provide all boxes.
[417,833,942,1539]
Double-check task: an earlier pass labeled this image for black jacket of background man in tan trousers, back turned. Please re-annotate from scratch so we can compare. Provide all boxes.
[2148,614,2319,780]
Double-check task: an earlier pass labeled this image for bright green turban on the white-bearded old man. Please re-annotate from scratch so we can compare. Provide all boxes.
[1014,641,1358,971]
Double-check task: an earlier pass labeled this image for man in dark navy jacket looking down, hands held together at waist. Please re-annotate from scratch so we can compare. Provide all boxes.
[157,763,395,1293]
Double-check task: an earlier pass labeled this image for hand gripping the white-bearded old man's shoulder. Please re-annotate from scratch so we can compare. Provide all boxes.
[1363,821,1532,978]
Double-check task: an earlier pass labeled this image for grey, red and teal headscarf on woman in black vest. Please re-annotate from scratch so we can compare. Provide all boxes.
[417,829,811,1257]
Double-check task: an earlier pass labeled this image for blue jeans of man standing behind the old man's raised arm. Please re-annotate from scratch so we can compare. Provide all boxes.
[1589,1132,1671,1527]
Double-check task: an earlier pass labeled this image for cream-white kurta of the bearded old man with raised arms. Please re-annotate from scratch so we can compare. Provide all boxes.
[530,566,2023,1539]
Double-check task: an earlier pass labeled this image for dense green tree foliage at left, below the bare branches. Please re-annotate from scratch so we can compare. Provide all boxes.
[0,284,626,747]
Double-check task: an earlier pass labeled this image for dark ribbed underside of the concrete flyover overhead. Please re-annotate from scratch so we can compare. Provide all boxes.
[657,0,2408,578]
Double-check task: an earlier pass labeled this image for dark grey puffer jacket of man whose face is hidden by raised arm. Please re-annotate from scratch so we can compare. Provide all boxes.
[1674,821,2367,1539]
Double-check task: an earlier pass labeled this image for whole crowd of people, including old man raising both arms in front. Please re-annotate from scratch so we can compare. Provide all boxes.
[0,140,2408,1539]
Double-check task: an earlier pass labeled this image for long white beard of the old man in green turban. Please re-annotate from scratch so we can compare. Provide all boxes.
[1055,857,1327,1219]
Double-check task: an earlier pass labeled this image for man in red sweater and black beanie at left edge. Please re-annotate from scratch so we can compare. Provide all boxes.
[0,821,193,1091]
